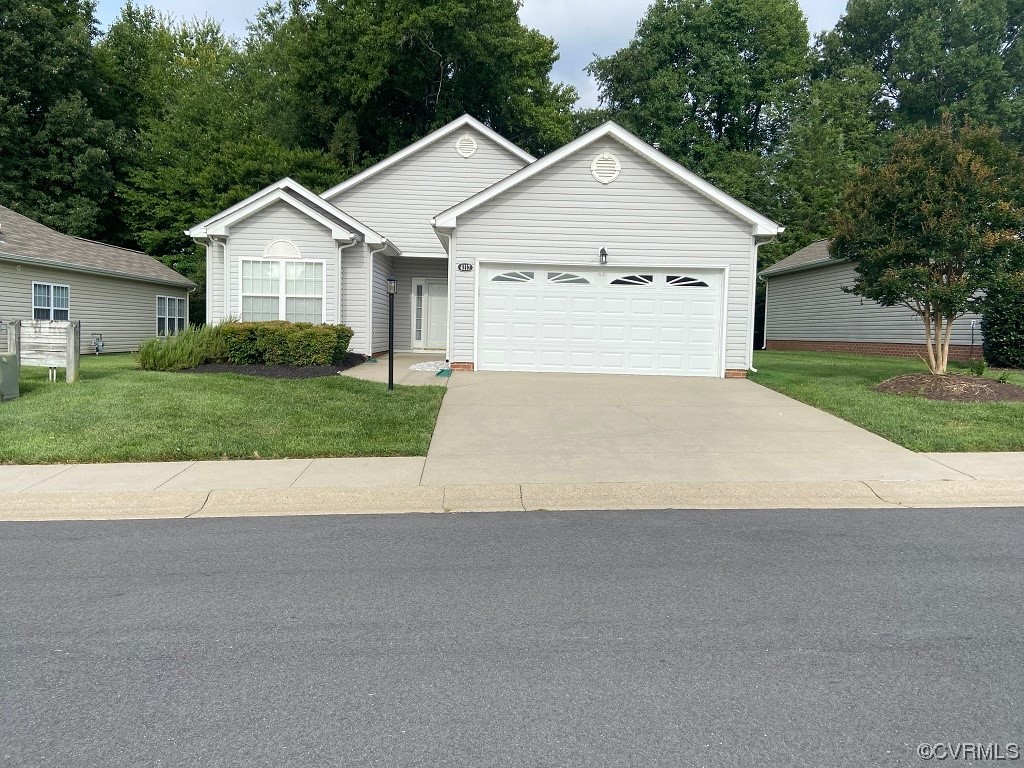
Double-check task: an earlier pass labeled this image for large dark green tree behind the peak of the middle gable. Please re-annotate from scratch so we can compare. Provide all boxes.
[251,0,577,167]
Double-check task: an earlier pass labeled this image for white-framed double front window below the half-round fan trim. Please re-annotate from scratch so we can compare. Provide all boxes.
[242,261,324,323]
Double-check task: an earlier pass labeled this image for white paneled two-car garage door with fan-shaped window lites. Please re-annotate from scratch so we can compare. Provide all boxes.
[476,264,724,376]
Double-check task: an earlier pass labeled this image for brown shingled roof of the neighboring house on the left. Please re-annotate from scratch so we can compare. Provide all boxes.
[0,206,196,288]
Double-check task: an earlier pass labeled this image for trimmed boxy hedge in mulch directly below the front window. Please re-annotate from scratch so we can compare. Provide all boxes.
[220,321,352,366]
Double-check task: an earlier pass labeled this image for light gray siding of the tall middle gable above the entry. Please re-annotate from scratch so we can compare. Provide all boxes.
[329,128,526,256]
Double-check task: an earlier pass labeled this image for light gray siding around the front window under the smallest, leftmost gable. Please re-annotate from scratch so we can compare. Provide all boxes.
[227,202,337,321]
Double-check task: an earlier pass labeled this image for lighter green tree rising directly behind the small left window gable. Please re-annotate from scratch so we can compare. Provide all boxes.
[106,6,344,322]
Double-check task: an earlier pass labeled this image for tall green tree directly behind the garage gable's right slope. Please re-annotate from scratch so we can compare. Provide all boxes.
[588,0,808,165]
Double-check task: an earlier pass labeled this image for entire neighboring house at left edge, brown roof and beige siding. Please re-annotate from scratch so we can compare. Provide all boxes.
[0,206,196,352]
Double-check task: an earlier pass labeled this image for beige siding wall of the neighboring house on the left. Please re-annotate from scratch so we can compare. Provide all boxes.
[0,261,188,354]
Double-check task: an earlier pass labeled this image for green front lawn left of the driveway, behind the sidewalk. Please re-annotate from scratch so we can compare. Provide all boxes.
[0,354,444,464]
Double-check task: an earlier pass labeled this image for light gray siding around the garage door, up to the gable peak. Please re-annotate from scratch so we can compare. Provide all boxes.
[452,138,756,369]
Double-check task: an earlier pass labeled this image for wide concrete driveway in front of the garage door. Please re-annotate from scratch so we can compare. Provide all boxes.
[422,372,964,484]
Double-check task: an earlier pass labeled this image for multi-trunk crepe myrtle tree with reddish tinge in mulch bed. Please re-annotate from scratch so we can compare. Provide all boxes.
[829,119,1024,374]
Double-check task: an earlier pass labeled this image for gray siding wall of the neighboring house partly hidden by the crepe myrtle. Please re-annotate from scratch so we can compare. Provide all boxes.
[765,262,981,346]
